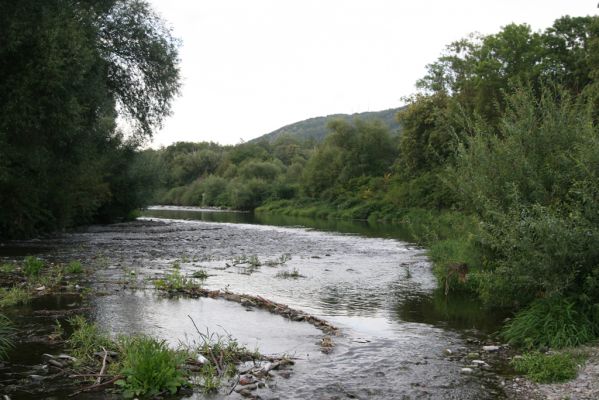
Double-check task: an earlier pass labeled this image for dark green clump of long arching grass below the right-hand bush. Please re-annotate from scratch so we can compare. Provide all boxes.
[502,296,599,349]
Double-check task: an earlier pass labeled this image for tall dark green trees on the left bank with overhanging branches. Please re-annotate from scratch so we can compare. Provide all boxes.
[0,0,179,238]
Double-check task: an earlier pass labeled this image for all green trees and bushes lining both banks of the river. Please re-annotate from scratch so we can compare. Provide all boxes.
[0,0,599,394]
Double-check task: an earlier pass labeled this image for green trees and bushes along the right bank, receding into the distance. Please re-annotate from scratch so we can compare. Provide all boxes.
[150,17,599,347]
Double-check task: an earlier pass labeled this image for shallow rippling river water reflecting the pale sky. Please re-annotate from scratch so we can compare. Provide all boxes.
[0,207,503,399]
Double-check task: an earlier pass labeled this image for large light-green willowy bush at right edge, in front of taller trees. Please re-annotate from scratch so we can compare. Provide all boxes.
[450,88,599,305]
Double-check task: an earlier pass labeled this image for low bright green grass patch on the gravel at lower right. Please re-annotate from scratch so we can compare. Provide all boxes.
[511,352,583,383]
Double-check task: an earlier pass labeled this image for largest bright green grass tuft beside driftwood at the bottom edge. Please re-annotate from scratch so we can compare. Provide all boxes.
[116,336,187,398]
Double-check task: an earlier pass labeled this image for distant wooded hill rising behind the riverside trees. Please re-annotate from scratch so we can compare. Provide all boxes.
[250,108,401,142]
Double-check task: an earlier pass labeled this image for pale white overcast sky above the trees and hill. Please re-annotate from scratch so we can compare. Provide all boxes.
[149,0,599,148]
